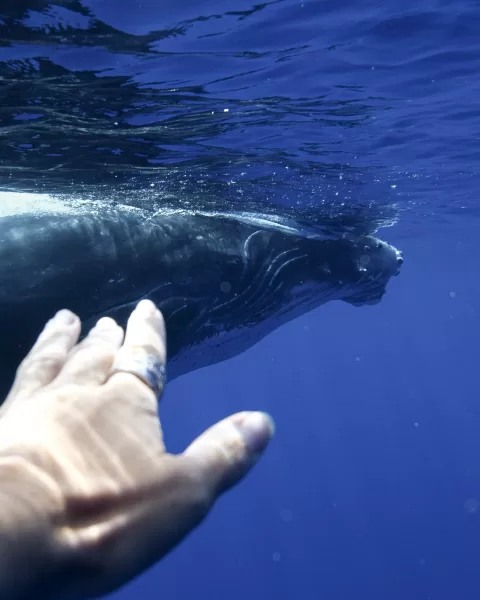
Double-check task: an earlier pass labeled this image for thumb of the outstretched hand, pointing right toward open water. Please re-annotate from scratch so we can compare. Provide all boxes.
[184,412,275,500]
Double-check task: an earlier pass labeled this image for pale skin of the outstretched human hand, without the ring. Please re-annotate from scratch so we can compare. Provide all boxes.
[0,300,273,600]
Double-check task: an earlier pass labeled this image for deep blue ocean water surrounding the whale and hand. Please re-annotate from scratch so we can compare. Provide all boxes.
[0,0,480,600]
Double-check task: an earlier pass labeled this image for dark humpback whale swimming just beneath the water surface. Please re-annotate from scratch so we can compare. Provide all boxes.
[0,203,403,394]
